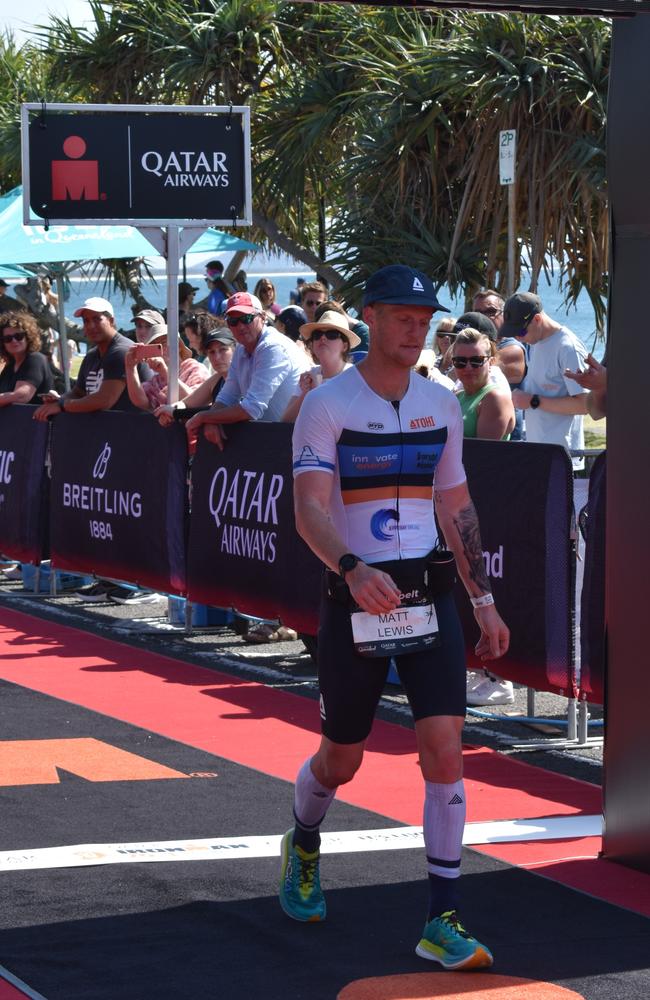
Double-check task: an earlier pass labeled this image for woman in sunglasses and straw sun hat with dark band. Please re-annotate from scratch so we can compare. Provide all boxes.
[282,310,361,423]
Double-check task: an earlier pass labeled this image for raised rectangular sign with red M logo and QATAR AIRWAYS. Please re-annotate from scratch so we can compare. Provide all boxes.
[23,104,251,225]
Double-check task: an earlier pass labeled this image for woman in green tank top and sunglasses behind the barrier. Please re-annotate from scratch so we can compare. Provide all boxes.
[451,327,515,441]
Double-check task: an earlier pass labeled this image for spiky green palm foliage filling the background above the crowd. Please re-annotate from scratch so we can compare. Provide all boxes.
[0,0,610,330]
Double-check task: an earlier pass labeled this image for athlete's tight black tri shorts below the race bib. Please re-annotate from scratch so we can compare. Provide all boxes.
[318,577,467,743]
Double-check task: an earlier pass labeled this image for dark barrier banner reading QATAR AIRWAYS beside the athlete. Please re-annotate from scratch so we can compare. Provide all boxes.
[188,422,322,635]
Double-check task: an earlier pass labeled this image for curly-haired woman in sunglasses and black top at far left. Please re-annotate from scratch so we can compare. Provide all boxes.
[0,312,53,406]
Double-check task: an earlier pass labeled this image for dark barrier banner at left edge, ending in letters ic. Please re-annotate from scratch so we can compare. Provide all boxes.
[0,403,49,564]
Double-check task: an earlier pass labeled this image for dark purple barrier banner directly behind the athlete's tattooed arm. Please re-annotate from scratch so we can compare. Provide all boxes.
[456,440,575,694]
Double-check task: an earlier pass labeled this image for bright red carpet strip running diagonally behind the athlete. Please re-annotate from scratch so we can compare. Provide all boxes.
[0,609,650,916]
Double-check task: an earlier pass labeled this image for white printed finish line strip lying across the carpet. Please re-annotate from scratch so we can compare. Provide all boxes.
[0,816,602,872]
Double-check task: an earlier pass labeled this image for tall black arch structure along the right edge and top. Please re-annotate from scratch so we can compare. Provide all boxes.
[312,0,650,871]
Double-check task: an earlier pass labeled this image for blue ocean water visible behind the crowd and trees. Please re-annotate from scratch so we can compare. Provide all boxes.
[58,254,604,358]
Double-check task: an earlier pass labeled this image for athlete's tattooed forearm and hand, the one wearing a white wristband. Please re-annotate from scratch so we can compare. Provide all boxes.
[435,483,510,660]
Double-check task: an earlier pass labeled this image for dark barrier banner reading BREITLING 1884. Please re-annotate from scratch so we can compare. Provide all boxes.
[50,412,187,594]
